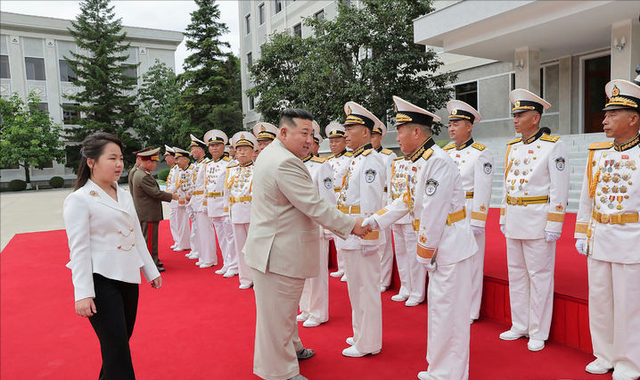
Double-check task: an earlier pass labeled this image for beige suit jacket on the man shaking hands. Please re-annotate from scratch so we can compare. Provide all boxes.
[243,139,355,278]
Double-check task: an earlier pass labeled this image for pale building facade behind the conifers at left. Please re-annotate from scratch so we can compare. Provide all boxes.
[0,12,183,184]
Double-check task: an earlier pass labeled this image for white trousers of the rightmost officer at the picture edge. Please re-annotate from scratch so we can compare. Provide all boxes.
[587,258,640,379]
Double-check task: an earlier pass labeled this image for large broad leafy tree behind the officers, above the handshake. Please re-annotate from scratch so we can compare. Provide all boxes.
[247,0,455,134]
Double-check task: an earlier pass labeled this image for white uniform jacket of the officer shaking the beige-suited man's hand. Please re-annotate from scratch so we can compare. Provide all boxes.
[374,138,478,266]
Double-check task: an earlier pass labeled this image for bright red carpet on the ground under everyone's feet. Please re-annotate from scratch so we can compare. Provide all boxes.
[0,222,610,380]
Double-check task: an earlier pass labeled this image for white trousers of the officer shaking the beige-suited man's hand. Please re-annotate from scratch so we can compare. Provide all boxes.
[427,258,472,380]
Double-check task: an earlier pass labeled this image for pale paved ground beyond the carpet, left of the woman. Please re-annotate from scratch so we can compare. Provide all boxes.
[0,185,169,249]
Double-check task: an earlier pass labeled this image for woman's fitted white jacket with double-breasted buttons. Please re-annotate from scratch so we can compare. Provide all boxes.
[62,180,160,302]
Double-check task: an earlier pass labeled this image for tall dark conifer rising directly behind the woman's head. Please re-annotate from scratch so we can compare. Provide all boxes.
[64,0,140,168]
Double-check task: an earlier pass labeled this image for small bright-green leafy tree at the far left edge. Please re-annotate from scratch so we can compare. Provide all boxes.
[0,92,64,183]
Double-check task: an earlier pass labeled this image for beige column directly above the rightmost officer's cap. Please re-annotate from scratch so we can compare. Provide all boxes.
[611,19,640,80]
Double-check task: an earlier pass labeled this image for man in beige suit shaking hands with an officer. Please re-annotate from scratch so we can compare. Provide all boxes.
[244,109,370,380]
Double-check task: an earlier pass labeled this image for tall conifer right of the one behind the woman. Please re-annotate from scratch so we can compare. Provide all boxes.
[179,0,242,136]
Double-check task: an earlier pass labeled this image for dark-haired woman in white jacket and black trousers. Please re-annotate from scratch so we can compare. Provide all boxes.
[63,132,162,380]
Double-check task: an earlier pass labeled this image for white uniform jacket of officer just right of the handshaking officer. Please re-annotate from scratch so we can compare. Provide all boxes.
[444,138,493,228]
